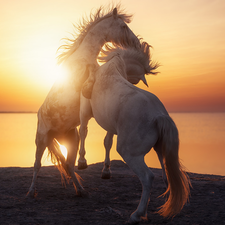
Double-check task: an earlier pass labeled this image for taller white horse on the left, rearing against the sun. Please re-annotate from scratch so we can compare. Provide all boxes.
[27,6,140,196]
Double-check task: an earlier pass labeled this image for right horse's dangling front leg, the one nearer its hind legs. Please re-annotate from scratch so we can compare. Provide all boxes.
[102,132,113,179]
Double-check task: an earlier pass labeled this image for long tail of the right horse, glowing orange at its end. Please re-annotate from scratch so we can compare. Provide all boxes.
[156,115,191,217]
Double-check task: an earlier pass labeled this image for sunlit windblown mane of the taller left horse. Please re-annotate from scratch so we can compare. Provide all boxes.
[57,4,132,64]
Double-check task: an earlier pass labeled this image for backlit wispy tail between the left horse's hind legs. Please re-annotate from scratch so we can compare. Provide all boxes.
[48,139,69,185]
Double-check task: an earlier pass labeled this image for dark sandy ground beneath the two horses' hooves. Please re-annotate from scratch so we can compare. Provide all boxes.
[0,161,225,225]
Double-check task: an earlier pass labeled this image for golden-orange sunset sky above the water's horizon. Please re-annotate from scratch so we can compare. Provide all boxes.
[0,0,225,112]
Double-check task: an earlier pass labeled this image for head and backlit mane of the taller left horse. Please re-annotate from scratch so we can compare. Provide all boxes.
[57,5,140,64]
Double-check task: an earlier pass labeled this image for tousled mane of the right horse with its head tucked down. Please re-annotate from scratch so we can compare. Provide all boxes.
[98,40,160,75]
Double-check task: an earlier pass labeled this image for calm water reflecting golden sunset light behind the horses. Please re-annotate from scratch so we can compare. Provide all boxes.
[0,113,225,175]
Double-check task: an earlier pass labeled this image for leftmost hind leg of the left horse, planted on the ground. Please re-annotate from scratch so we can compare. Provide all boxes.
[27,133,47,197]
